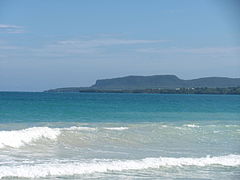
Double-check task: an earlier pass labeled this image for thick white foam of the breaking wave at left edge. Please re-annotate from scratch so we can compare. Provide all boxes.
[0,127,60,148]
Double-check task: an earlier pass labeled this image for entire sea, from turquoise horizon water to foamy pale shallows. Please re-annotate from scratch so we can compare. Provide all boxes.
[0,92,240,180]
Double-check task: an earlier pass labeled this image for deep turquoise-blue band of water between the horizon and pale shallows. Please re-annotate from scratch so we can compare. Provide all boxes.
[0,92,240,122]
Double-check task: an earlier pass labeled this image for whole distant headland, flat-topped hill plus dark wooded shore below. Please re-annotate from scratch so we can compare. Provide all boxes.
[44,75,240,94]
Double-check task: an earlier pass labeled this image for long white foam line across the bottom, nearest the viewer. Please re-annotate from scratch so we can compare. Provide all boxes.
[0,155,240,178]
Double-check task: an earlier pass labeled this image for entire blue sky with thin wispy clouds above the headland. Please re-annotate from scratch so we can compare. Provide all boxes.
[0,0,240,91]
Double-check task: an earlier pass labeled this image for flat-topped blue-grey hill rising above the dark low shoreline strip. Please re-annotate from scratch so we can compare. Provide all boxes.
[45,75,240,92]
